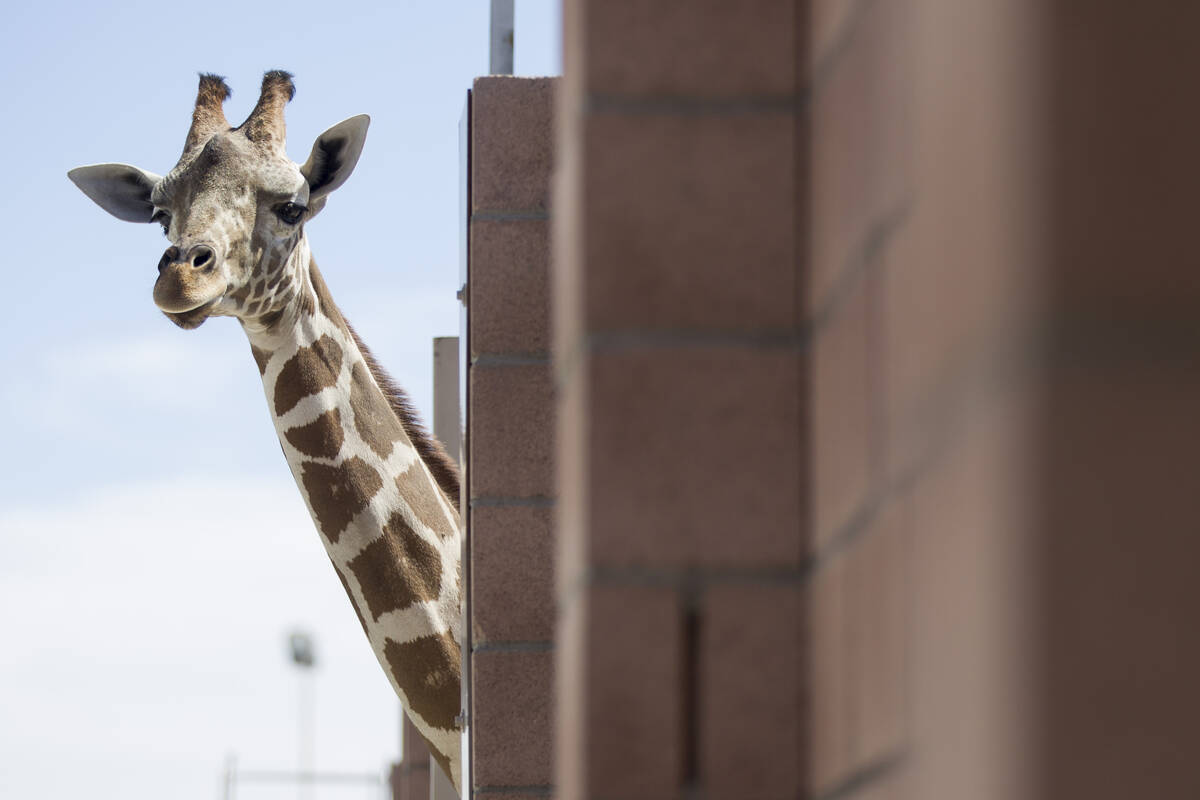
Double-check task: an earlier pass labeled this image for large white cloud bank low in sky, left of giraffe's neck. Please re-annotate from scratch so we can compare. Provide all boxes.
[0,476,398,800]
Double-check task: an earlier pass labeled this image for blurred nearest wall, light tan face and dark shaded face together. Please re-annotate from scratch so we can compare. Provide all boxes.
[809,0,1200,799]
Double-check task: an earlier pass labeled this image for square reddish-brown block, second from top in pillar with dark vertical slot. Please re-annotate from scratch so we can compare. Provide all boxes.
[578,113,803,333]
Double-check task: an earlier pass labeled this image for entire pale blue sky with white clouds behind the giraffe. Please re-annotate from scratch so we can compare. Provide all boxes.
[0,0,560,800]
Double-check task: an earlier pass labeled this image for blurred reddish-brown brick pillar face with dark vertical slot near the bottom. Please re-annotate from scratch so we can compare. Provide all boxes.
[553,0,810,799]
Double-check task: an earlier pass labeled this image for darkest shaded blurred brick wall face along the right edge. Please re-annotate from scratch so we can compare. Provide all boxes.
[1034,0,1200,800]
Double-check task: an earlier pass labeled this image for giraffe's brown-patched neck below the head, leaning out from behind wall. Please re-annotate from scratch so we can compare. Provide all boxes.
[245,239,462,788]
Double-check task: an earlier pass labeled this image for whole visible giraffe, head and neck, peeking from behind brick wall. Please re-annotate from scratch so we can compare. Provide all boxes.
[68,71,462,790]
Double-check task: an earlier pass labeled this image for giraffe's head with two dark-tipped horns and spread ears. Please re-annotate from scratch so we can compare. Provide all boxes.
[68,71,370,327]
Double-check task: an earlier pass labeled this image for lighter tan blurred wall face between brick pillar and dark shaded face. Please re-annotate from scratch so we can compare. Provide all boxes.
[805,0,1042,800]
